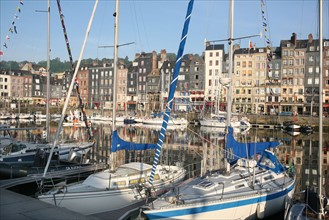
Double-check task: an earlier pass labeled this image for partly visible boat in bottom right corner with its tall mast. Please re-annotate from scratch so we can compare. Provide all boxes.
[285,0,329,220]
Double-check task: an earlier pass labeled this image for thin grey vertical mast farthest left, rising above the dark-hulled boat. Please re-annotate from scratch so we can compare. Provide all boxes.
[46,0,50,142]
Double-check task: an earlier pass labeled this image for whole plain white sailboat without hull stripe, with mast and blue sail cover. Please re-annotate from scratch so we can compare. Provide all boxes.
[38,0,186,215]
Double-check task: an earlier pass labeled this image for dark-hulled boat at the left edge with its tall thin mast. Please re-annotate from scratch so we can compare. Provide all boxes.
[0,0,94,170]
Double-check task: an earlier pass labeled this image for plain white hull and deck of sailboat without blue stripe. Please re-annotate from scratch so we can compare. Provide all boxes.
[38,164,185,215]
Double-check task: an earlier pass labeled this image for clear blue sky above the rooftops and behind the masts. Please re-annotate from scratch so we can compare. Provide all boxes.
[0,0,329,62]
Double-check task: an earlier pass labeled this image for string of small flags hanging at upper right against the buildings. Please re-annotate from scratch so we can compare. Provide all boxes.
[260,0,273,97]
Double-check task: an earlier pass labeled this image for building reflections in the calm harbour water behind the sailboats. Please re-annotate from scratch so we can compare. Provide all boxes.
[1,120,329,196]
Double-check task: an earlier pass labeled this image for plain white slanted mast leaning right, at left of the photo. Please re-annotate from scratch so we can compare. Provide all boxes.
[41,0,98,179]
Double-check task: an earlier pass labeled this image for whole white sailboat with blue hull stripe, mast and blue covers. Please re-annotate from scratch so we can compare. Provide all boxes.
[142,1,295,219]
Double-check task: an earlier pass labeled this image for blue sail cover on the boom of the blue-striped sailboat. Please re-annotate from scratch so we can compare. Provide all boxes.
[226,127,280,163]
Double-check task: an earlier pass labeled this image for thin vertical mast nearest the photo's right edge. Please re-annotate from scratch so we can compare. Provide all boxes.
[318,0,324,219]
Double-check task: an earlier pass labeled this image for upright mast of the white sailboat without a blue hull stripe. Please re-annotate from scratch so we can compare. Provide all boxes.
[110,0,119,171]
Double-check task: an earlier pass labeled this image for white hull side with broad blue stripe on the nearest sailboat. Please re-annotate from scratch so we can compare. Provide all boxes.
[145,188,293,220]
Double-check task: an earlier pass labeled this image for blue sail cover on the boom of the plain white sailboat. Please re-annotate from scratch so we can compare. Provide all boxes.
[111,131,157,152]
